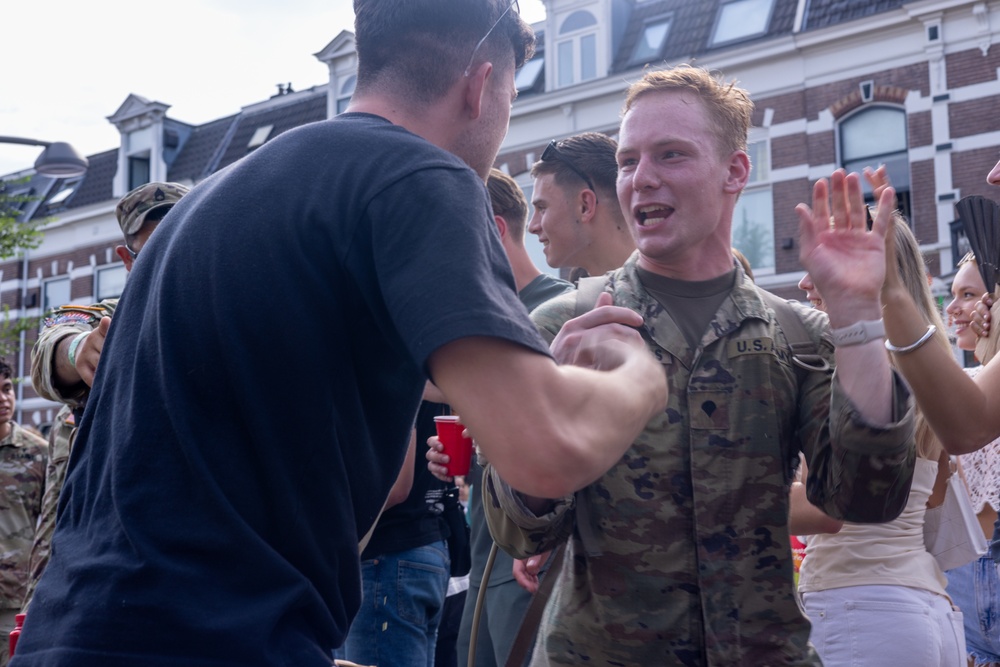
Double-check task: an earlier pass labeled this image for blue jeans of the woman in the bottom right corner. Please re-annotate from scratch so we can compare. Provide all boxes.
[945,553,1000,665]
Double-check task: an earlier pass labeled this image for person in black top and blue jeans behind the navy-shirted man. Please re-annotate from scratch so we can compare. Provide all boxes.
[336,401,451,667]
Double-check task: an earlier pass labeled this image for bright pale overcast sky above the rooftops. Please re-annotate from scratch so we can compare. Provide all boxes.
[0,0,545,175]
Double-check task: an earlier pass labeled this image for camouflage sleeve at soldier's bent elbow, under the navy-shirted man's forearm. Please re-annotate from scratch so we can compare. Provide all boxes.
[482,464,575,558]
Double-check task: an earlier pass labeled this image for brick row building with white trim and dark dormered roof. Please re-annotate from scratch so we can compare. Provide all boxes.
[0,0,1000,423]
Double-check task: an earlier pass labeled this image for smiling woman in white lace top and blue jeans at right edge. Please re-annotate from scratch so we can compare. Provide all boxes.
[946,253,1000,667]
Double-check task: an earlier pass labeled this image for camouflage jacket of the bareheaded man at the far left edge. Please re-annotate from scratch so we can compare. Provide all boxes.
[0,422,48,609]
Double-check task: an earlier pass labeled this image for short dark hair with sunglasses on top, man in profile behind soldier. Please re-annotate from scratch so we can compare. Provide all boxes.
[531,132,618,201]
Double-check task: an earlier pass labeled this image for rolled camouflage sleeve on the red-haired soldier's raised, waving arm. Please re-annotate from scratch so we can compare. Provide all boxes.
[805,371,916,523]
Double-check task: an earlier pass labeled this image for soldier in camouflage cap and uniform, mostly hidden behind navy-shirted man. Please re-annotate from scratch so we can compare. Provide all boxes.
[24,183,188,608]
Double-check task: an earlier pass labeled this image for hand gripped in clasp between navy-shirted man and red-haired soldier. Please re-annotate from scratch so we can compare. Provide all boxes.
[550,292,646,370]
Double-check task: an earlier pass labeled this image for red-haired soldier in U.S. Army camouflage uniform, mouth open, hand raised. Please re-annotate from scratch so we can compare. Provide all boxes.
[484,66,914,667]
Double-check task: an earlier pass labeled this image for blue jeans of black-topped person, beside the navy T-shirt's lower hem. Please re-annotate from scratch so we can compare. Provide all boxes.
[343,540,451,667]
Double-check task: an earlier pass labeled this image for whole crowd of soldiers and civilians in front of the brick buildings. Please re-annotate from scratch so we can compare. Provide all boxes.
[0,0,1000,667]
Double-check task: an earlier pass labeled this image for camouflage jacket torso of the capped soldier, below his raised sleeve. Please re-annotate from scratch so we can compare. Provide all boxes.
[23,405,76,611]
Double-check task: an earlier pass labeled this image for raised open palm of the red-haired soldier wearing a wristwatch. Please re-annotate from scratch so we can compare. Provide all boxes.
[795,169,896,327]
